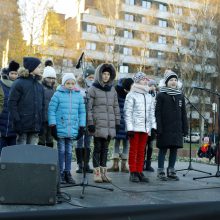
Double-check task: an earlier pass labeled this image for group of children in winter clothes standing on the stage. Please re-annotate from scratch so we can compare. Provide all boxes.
[0,57,188,184]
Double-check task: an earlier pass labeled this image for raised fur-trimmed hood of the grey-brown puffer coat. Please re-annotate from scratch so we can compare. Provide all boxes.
[94,63,116,86]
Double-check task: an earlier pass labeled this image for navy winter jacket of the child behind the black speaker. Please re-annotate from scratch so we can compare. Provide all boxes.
[8,75,44,133]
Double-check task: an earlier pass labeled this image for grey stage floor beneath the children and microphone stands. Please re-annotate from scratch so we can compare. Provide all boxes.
[0,162,220,213]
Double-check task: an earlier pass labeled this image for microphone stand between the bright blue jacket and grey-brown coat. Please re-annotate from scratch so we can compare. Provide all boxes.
[62,53,114,199]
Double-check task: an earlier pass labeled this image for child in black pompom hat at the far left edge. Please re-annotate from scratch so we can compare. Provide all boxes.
[0,60,19,154]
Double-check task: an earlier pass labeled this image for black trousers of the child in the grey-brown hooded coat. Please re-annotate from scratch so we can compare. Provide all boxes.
[93,137,110,168]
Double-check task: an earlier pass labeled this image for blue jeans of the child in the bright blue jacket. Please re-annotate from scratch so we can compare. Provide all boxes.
[57,138,73,173]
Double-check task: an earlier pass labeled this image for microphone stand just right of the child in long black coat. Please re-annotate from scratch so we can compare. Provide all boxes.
[176,96,211,176]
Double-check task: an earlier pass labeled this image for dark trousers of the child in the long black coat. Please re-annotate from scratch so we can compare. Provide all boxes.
[158,148,177,169]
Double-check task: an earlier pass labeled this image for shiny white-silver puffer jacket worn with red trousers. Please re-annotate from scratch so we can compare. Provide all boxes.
[124,83,156,135]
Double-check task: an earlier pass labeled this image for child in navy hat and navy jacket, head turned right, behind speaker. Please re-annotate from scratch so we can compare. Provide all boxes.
[8,57,44,145]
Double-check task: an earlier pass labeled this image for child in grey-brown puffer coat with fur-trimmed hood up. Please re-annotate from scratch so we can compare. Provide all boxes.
[88,63,120,183]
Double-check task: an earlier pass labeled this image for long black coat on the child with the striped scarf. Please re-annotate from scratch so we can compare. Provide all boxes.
[155,92,188,148]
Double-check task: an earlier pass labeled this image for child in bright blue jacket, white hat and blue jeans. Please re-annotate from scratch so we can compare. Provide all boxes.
[48,73,86,184]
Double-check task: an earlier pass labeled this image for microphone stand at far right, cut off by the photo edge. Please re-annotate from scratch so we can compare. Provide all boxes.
[193,87,220,180]
